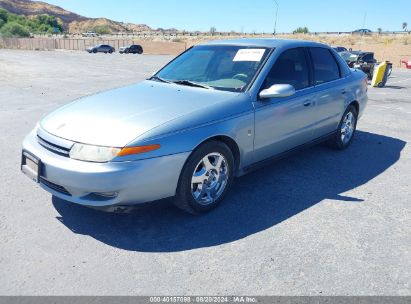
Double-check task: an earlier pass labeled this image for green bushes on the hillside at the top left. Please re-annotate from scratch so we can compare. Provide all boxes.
[0,8,63,37]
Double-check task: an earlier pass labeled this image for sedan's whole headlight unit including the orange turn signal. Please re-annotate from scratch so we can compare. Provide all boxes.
[70,144,160,163]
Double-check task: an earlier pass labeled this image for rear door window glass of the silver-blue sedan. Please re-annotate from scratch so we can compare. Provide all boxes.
[310,47,340,84]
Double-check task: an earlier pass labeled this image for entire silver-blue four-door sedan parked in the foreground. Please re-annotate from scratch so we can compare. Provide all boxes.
[21,39,367,214]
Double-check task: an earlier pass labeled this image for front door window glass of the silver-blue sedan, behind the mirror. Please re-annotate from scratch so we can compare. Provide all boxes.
[264,48,310,90]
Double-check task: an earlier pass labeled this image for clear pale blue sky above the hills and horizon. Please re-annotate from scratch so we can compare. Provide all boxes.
[43,0,411,33]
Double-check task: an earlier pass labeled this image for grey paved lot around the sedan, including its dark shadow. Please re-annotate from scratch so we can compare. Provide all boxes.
[0,50,411,295]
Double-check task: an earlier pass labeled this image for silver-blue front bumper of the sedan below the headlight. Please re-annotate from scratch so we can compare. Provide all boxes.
[23,131,190,207]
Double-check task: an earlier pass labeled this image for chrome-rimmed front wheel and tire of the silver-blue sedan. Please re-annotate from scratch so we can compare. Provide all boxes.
[174,141,235,214]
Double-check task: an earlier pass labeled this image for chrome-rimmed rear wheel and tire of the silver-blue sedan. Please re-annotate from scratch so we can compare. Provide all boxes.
[328,105,358,150]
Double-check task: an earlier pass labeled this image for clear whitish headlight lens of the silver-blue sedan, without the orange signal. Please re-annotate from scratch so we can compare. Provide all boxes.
[70,144,121,163]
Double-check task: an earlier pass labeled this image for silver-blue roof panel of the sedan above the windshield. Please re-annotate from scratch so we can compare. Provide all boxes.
[200,38,329,48]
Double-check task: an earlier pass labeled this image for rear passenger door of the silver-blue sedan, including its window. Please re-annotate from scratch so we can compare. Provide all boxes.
[309,47,347,137]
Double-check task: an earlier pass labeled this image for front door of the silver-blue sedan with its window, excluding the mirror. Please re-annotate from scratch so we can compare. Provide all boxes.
[254,48,317,162]
